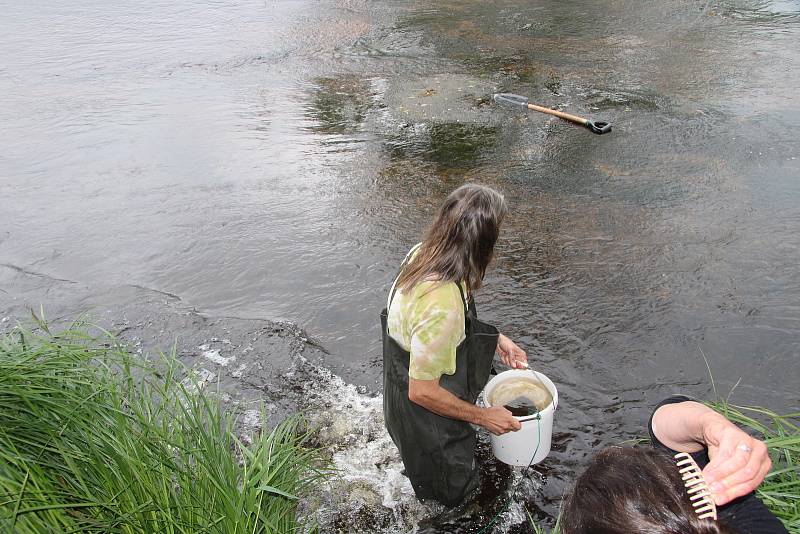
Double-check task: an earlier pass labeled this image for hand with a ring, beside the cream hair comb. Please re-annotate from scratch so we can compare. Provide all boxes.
[703,414,772,506]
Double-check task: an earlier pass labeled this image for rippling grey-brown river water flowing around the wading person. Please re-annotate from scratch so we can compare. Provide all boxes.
[0,0,800,532]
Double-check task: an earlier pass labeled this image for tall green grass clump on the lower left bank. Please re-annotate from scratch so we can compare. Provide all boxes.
[0,325,327,534]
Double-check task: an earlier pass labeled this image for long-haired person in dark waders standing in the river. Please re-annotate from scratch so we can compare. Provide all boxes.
[381,184,527,506]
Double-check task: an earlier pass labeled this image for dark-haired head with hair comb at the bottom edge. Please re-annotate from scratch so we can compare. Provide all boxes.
[561,447,734,534]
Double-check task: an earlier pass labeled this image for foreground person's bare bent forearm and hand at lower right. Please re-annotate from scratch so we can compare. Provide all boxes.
[653,401,772,505]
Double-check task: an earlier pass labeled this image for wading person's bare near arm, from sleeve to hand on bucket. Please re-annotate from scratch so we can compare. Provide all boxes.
[408,378,522,435]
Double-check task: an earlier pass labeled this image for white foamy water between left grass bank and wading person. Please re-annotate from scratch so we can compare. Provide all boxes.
[284,356,442,532]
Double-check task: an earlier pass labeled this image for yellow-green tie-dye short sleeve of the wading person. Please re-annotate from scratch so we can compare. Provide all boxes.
[408,282,464,380]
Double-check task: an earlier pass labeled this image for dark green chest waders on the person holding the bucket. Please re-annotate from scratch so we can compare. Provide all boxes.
[381,284,499,506]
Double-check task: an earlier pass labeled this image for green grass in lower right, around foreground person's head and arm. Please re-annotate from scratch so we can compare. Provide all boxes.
[528,400,800,534]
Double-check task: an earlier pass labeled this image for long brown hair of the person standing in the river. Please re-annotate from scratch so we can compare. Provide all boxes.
[397,184,508,293]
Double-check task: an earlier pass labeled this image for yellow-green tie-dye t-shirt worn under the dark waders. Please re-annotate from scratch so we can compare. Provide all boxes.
[387,249,464,380]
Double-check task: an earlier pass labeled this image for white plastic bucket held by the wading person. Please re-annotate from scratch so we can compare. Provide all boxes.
[483,369,558,466]
